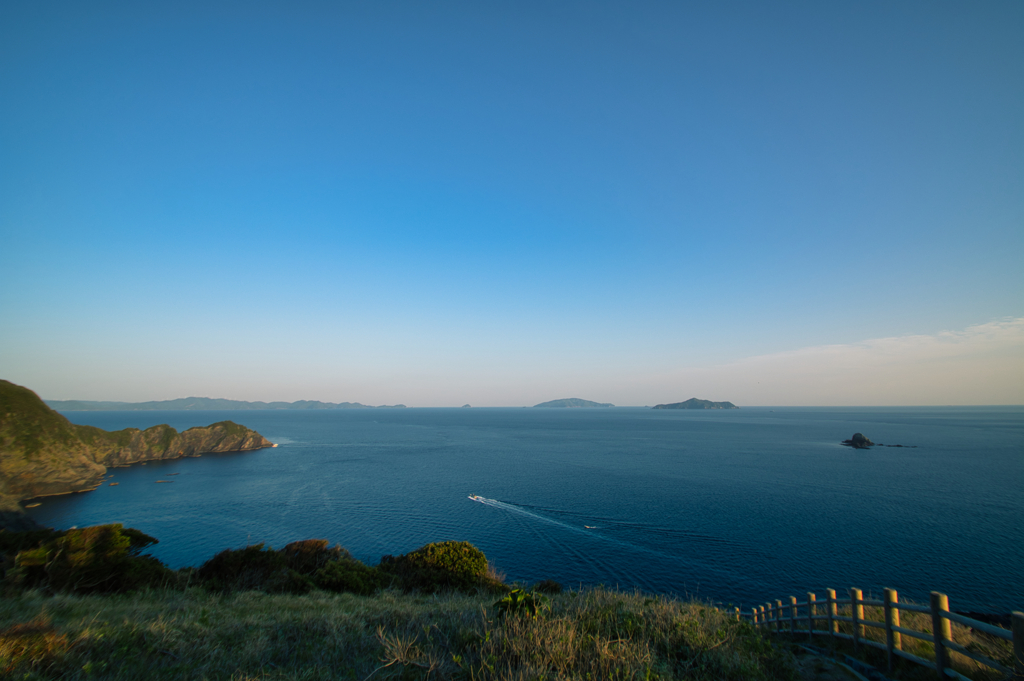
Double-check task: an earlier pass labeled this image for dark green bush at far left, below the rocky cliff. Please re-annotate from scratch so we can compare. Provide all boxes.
[8,523,172,593]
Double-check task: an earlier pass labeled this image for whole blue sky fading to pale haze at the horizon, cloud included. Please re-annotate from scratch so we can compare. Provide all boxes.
[0,0,1024,407]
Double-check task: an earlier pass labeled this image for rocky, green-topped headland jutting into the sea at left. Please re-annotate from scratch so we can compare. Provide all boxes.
[0,380,271,526]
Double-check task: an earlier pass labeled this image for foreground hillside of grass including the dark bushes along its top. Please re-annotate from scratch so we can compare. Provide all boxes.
[0,524,791,680]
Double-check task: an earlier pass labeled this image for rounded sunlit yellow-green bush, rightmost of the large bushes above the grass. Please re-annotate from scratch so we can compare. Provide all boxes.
[379,542,499,593]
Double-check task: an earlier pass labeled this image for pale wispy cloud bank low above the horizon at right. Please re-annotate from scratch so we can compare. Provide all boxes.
[657,317,1024,406]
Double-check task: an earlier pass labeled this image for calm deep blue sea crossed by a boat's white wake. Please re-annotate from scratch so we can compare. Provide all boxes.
[25,407,1024,612]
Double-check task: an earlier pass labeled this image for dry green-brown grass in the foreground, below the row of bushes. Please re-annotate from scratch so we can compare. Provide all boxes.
[0,588,794,681]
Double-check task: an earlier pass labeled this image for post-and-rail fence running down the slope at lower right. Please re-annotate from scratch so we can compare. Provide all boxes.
[735,589,1024,681]
